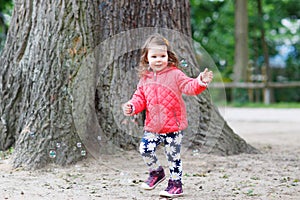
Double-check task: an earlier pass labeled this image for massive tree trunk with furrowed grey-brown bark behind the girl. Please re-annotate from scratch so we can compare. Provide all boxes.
[0,0,255,168]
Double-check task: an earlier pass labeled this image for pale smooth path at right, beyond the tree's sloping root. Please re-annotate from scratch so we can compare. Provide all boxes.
[220,108,300,146]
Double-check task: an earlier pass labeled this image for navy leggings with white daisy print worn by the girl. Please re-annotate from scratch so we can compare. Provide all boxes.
[140,131,183,180]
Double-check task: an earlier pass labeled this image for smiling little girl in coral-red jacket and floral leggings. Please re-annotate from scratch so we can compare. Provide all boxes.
[122,34,213,197]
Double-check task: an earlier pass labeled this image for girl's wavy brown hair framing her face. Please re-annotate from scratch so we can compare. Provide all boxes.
[138,33,179,77]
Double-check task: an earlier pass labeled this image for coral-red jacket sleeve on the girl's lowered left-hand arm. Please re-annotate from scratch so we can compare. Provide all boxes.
[130,83,146,115]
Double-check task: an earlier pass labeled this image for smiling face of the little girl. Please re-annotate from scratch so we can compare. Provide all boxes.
[147,45,168,71]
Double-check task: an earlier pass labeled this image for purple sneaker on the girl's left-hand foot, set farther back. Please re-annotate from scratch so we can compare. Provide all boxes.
[141,166,166,190]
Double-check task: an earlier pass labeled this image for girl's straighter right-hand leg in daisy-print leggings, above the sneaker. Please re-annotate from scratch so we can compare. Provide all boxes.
[164,131,183,181]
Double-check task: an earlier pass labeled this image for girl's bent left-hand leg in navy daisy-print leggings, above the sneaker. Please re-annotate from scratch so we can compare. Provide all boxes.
[140,131,161,171]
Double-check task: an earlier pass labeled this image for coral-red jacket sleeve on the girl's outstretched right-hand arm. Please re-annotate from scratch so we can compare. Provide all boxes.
[176,70,207,95]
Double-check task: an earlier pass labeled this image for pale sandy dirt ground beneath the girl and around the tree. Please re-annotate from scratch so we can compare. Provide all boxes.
[0,108,300,200]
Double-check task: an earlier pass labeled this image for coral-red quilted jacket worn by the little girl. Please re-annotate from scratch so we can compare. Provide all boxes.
[130,67,207,133]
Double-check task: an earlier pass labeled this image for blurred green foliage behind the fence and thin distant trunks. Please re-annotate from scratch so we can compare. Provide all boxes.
[0,0,300,104]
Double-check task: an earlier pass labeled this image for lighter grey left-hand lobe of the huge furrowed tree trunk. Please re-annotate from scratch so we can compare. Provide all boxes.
[0,0,97,168]
